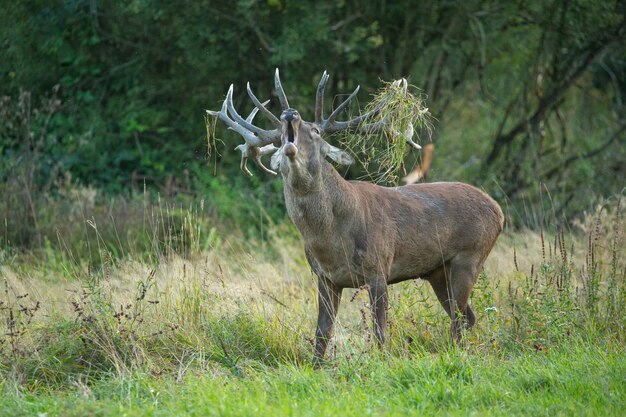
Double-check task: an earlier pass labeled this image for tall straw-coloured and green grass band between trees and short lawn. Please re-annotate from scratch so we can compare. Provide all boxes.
[0,188,626,392]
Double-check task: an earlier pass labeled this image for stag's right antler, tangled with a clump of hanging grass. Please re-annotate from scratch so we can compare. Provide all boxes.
[315,71,421,149]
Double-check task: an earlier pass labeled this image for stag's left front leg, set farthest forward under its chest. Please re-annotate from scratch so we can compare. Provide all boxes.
[315,276,342,365]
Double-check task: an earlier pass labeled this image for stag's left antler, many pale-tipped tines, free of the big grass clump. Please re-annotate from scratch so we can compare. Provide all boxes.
[206,83,286,176]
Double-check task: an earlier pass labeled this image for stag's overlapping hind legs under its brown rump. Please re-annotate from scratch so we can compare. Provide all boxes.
[428,256,482,342]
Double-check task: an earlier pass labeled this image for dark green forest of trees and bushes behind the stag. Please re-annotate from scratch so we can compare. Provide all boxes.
[0,0,626,248]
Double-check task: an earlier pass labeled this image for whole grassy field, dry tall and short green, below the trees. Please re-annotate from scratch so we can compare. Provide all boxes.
[0,199,626,416]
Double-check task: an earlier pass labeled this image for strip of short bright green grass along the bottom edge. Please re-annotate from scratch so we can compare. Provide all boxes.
[0,346,626,416]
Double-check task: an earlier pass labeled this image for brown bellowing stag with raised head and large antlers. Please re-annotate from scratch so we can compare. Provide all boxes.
[207,69,504,364]
